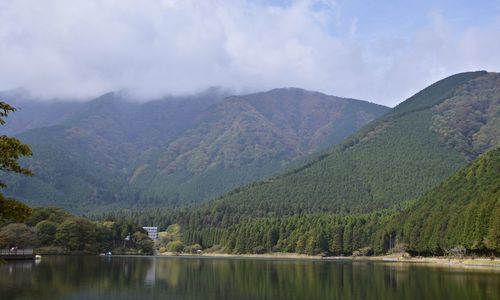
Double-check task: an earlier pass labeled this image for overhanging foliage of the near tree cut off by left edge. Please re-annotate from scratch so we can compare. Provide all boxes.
[0,101,32,222]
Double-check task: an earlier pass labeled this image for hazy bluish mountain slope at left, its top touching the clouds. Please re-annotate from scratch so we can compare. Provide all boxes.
[2,90,226,212]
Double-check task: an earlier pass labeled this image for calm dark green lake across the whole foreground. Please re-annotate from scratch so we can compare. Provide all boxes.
[0,256,500,300]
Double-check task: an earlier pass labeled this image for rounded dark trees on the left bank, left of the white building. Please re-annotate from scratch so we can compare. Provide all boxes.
[0,207,153,254]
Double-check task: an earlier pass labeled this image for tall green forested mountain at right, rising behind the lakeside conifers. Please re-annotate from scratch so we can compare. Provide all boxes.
[191,71,500,227]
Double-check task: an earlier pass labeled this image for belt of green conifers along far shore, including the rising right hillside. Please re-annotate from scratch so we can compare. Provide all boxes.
[171,148,500,255]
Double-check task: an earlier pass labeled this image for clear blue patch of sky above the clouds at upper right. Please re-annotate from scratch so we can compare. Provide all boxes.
[274,0,500,37]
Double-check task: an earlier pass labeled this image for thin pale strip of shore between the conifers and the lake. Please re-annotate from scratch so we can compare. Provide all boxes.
[155,252,500,271]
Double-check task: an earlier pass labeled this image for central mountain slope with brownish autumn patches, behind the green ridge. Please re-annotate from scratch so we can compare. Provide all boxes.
[130,89,387,202]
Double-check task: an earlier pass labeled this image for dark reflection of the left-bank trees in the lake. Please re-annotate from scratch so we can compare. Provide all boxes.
[0,256,151,299]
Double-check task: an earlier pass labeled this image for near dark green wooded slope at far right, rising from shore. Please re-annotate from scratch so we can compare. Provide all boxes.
[392,148,500,254]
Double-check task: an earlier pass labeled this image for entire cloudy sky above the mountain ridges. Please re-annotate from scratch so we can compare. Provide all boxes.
[0,0,500,106]
